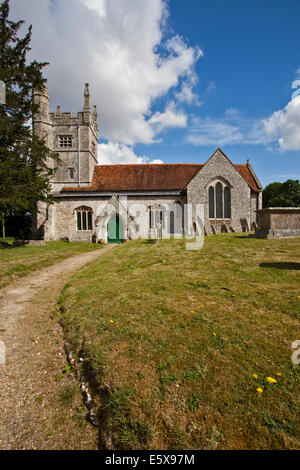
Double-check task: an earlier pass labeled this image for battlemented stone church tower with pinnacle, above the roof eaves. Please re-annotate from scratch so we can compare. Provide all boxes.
[33,83,98,193]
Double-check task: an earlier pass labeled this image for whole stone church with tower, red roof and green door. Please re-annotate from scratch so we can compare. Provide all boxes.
[33,84,262,243]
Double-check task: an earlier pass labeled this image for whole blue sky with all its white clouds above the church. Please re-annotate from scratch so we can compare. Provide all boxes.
[10,0,300,186]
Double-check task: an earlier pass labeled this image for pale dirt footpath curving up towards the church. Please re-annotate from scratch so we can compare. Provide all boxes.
[0,245,113,449]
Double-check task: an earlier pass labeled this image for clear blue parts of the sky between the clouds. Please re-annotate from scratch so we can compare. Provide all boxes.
[137,0,300,185]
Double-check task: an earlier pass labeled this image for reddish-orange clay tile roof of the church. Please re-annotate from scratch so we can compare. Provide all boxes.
[62,163,261,192]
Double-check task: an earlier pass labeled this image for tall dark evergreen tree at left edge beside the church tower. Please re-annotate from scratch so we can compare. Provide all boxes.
[0,0,58,239]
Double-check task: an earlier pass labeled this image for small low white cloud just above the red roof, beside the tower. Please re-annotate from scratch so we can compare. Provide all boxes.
[98,142,163,165]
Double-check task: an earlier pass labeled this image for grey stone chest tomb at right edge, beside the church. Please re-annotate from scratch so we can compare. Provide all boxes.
[254,207,300,238]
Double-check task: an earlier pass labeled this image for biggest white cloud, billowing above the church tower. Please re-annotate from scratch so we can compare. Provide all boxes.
[11,0,203,146]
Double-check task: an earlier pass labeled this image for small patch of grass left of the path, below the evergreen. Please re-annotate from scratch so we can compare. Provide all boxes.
[0,238,100,288]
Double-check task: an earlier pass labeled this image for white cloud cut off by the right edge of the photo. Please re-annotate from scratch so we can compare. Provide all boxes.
[263,96,300,151]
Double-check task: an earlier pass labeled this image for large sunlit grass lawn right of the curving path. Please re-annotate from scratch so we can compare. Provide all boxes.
[60,234,300,449]
